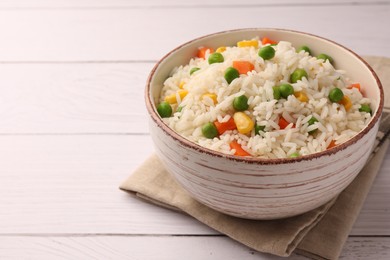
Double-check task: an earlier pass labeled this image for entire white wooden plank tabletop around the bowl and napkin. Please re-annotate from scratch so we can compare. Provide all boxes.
[0,0,390,259]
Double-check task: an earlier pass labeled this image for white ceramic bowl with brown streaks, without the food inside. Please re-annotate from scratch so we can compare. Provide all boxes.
[145,29,383,219]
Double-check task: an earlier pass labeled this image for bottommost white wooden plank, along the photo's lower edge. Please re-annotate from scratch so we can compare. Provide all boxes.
[0,236,390,260]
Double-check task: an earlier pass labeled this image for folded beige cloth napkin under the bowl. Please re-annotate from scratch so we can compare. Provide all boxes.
[120,57,390,259]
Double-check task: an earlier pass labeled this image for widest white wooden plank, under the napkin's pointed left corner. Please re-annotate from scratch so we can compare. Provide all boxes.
[0,135,390,235]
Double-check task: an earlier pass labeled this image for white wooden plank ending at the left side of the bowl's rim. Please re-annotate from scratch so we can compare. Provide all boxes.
[0,63,154,134]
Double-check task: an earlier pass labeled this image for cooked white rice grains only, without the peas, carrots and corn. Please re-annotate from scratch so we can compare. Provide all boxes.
[157,39,372,158]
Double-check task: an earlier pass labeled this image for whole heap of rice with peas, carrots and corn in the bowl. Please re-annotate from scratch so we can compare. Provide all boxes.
[157,38,372,158]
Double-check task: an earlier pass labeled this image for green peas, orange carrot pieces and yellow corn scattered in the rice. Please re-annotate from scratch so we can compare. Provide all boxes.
[157,37,372,158]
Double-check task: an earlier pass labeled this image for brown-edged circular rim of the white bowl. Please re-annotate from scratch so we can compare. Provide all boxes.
[145,27,384,165]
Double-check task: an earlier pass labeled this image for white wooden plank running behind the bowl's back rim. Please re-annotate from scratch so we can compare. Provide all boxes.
[0,5,390,62]
